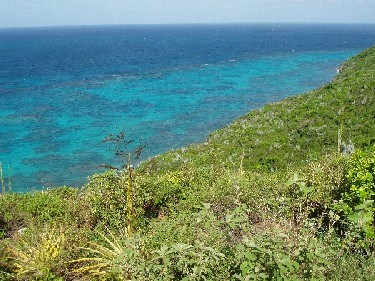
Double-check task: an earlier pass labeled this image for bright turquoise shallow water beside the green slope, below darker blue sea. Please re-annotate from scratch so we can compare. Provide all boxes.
[0,24,375,191]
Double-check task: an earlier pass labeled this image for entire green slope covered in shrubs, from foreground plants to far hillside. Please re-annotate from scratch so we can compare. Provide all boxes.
[0,48,375,280]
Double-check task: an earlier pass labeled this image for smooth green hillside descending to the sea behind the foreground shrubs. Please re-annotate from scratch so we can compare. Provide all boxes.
[147,48,375,171]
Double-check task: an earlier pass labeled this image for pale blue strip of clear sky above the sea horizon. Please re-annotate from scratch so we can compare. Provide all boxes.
[0,0,375,27]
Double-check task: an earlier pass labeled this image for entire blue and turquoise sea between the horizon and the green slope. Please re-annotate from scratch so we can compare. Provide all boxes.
[0,24,375,191]
